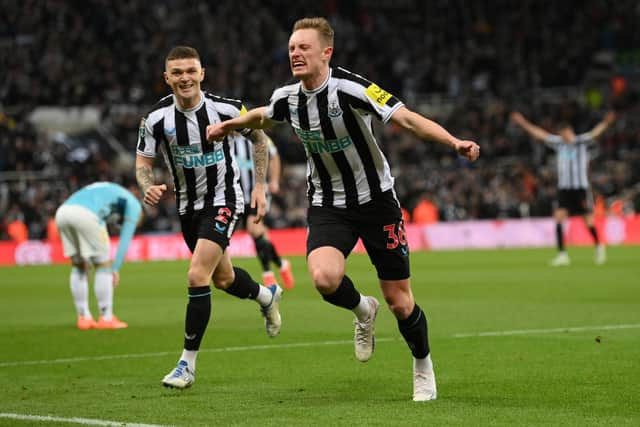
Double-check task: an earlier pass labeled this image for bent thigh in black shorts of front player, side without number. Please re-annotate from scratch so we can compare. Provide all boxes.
[307,206,358,258]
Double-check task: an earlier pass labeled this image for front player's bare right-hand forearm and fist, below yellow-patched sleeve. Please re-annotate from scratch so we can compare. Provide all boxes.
[391,106,480,161]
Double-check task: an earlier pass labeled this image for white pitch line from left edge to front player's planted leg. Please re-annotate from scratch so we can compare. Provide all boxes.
[0,338,395,368]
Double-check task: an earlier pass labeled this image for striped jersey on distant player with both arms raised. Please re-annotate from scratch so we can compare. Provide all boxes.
[545,132,594,190]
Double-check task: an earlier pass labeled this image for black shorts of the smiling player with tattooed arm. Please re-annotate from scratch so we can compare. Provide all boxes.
[180,206,238,253]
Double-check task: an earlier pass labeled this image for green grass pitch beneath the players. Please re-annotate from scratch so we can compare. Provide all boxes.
[0,247,640,426]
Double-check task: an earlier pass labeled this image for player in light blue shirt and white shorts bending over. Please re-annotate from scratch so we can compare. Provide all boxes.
[56,182,142,329]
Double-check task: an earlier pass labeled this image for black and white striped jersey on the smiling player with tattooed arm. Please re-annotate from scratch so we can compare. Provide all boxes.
[137,92,250,215]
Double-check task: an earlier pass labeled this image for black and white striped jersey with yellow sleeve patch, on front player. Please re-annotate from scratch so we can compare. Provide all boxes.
[267,68,404,207]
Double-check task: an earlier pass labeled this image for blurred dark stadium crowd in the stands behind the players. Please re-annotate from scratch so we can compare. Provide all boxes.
[0,0,640,240]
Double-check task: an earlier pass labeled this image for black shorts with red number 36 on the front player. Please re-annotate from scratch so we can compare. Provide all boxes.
[307,190,410,280]
